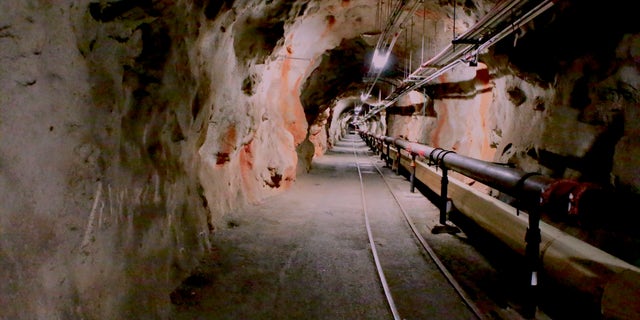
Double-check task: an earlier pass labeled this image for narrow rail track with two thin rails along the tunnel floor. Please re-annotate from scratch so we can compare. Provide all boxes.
[346,135,486,319]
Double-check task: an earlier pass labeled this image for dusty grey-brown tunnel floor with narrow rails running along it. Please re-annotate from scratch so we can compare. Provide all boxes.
[171,135,546,319]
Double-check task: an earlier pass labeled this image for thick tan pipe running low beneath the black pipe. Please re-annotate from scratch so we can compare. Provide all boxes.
[360,131,640,319]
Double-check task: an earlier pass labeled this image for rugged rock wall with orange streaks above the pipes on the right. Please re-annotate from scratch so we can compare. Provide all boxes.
[389,1,640,198]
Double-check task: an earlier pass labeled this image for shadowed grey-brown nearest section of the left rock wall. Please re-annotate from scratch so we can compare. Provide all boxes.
[0,1,212,319]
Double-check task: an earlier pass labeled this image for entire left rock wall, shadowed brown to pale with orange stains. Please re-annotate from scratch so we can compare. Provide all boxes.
[0,0,392,319]
